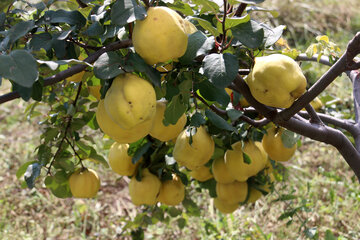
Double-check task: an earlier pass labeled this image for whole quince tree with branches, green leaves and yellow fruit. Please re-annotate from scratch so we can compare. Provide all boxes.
[0,0,360,237]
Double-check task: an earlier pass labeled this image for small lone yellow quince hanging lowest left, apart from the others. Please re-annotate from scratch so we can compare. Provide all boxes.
[69,168,100,198]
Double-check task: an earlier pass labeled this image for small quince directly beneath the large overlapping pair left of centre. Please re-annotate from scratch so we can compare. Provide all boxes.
[108,142,140,176]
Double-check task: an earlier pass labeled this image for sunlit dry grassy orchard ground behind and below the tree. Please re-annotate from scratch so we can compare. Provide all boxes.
[0,0,360,239]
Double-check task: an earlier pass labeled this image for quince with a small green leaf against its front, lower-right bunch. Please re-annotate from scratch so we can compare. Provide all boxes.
[225,141,267,182]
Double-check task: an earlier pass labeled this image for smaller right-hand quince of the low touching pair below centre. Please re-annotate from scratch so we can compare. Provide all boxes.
[158,174,185,206]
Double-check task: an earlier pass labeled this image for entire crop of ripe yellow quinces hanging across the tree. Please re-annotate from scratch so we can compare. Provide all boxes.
[69,7,306,213]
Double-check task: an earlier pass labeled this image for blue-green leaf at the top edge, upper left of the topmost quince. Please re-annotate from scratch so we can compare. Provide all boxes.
[110,0,147,26]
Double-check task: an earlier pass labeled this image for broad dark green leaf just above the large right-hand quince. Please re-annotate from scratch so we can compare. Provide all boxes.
[231,20,265,48]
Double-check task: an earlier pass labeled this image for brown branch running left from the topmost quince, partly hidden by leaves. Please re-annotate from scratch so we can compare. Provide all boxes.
[0,40,132,104]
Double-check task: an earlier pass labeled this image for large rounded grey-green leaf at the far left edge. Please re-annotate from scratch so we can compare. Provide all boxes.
[0,50,38,87]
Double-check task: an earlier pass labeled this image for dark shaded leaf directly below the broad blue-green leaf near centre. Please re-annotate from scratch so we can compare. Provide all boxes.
[197,81,230,107]
